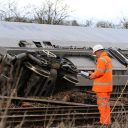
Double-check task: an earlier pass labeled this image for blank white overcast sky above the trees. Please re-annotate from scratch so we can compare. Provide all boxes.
[3,0,128,23]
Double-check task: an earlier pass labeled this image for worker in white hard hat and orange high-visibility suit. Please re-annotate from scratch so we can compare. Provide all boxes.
[89,44,112,125]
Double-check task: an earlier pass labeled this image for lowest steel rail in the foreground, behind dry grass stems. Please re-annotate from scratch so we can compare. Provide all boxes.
[0,111,128,124]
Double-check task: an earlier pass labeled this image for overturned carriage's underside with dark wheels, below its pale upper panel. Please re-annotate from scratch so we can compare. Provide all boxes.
[0,47,128,100]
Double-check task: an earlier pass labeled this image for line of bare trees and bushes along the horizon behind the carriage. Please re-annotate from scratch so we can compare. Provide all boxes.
[0,0,128,29]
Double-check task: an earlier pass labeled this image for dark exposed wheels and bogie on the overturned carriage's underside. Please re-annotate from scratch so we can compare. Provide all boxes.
[1,48,78,97]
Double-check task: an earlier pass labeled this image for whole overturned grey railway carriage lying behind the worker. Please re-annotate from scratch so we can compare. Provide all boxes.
[0,22,128,97]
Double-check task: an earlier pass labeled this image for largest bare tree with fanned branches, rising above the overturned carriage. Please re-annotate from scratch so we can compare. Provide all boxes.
[34,0,69,24]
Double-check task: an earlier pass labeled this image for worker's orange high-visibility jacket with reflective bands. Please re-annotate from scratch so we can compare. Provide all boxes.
[91,52,112,92]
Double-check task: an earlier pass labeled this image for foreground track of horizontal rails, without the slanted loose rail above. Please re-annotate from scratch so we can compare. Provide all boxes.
[0,105,128,127]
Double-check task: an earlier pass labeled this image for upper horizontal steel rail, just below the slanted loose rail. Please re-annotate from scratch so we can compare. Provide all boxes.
[0,105,128,114]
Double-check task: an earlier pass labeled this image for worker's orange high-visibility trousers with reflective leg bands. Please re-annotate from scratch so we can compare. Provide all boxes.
[96,92,111,124]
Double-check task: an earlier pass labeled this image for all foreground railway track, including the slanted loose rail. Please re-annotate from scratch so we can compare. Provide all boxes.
[0,96,128,128]
